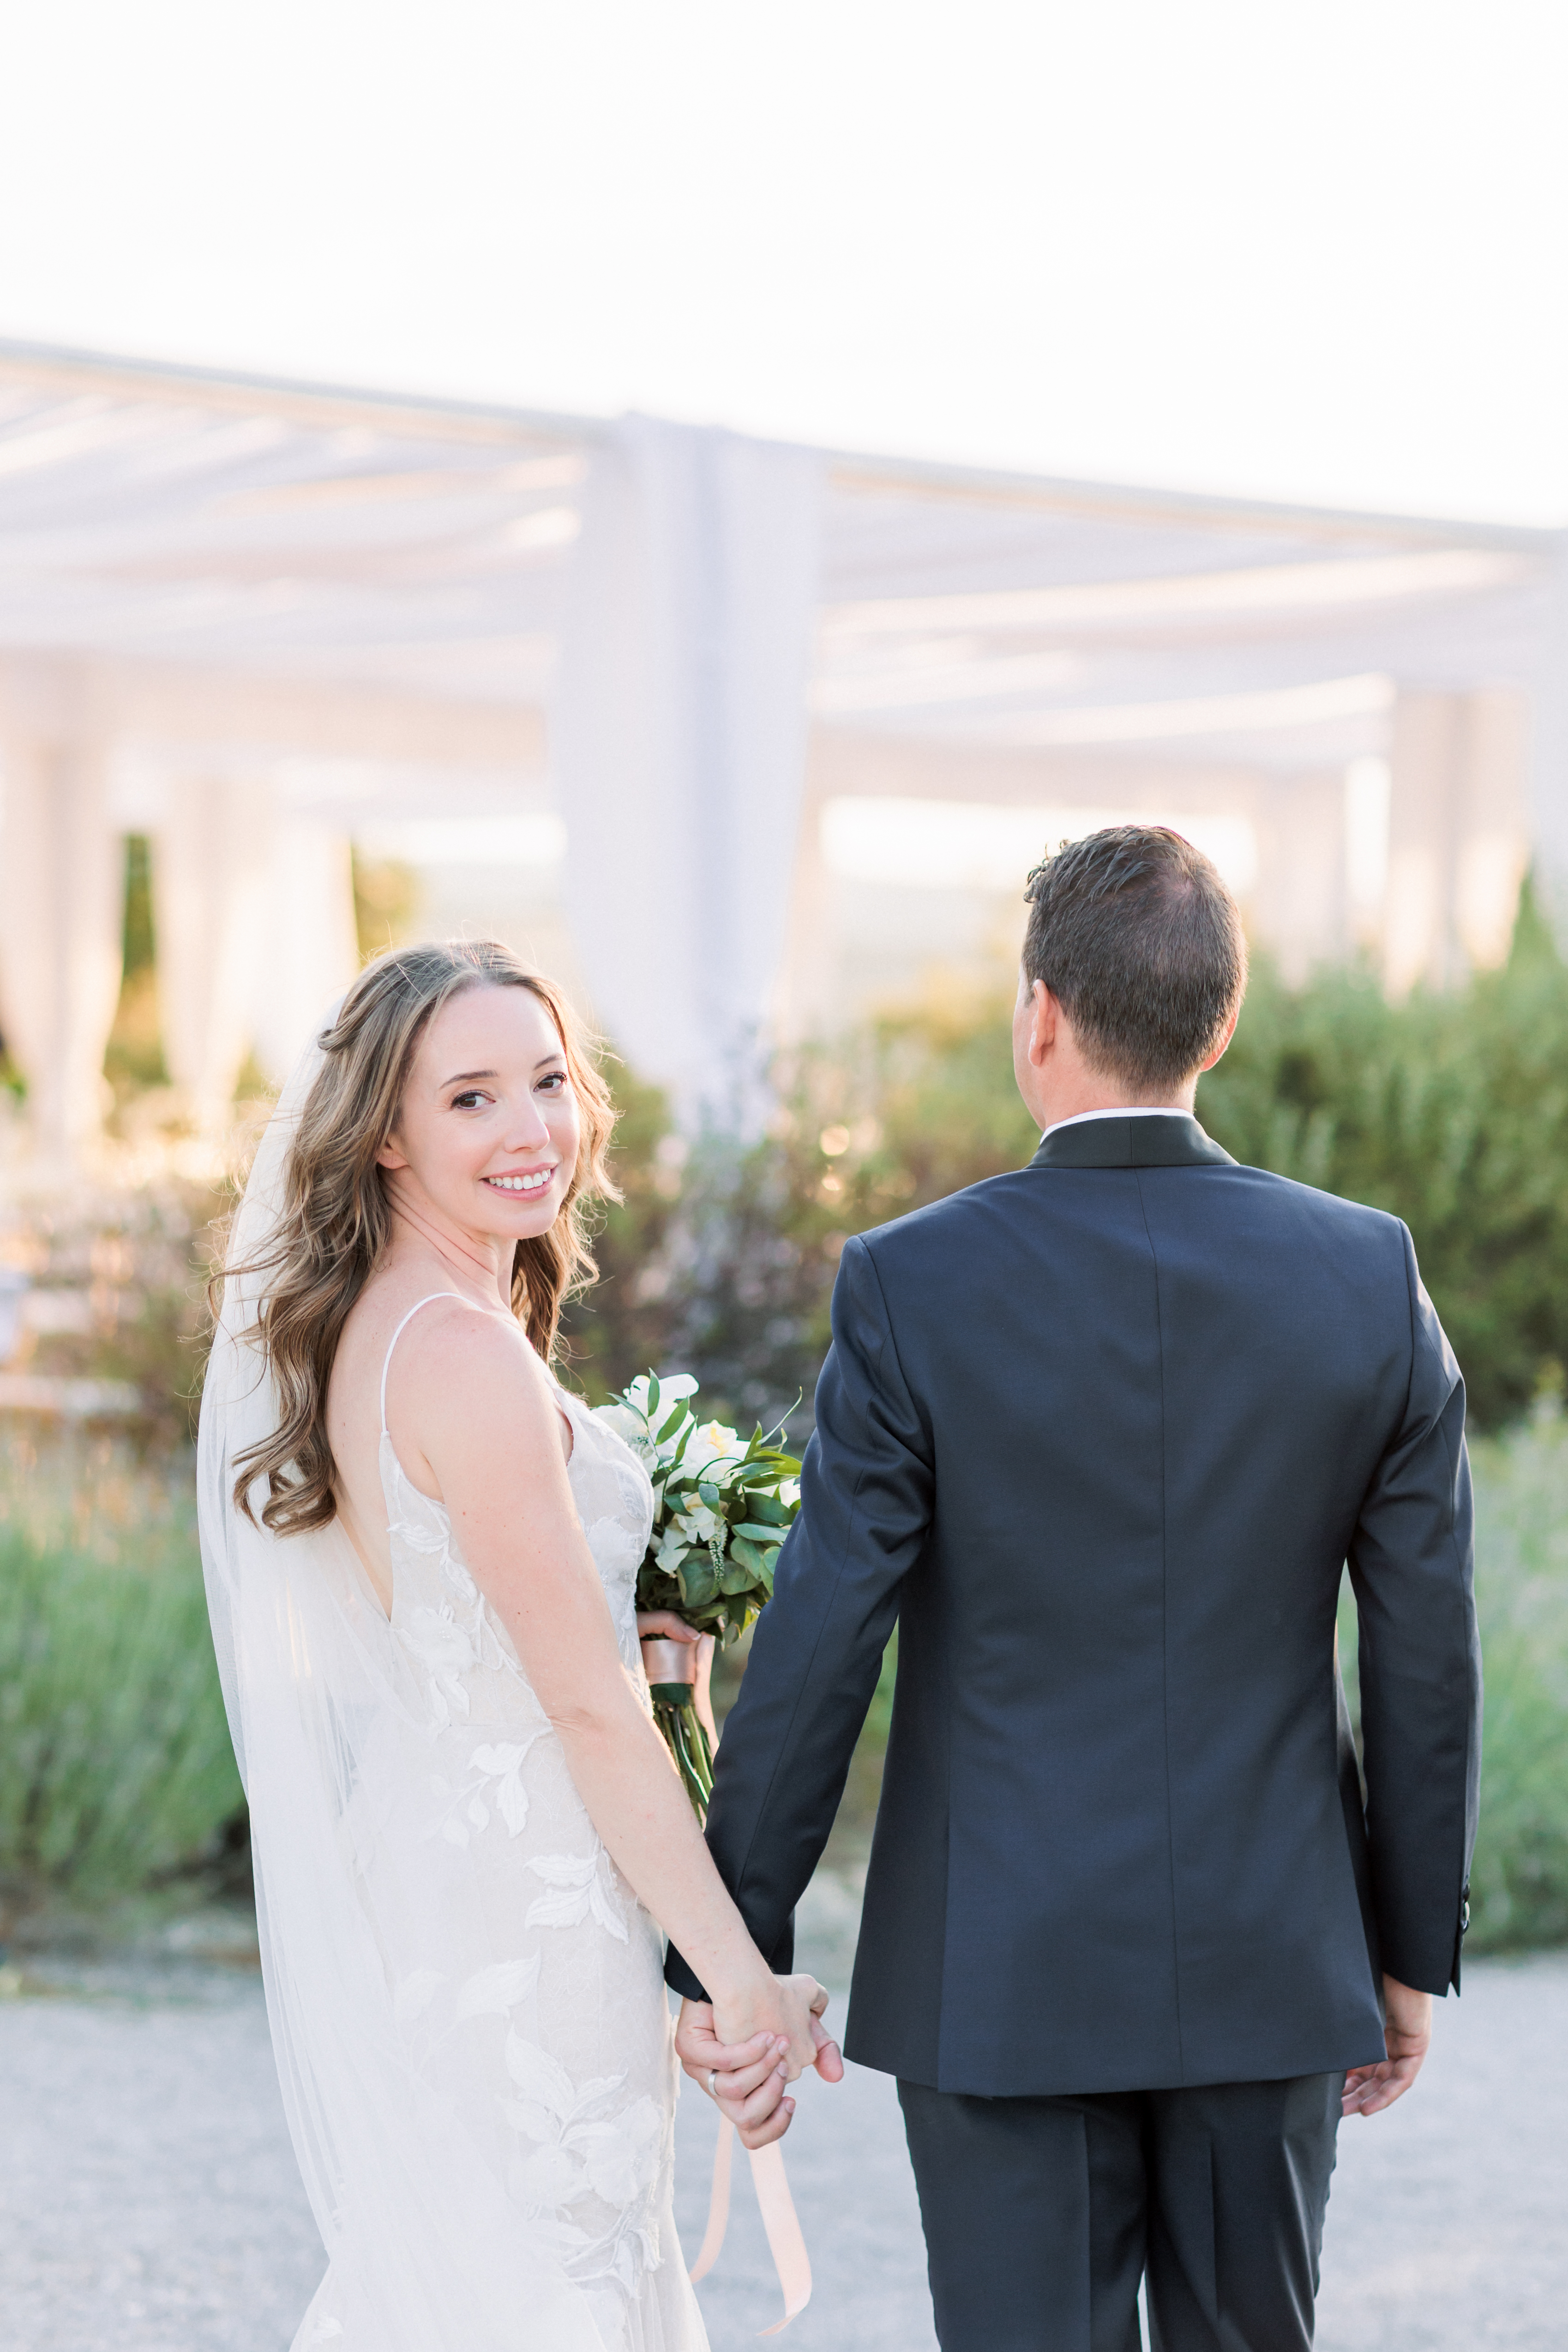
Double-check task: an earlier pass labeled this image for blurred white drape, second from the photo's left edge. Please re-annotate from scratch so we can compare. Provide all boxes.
[153,776,273,1136]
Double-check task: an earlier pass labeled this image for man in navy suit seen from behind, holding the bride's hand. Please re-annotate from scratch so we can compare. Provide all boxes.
[667,825,1481,2352]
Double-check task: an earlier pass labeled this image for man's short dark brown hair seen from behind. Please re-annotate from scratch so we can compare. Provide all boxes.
[1022,825,1246,1096]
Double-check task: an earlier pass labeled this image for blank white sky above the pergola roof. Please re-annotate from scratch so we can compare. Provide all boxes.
[0,0,1568,524]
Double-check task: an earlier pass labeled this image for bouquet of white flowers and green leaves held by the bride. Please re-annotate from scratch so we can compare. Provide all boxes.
[600,1371,799,1821]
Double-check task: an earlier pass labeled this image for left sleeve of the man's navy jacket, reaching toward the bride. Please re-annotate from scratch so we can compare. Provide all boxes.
[665,1239,931,1999]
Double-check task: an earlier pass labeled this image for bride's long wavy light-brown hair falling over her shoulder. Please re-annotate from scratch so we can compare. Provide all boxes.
[230,938,621,1536]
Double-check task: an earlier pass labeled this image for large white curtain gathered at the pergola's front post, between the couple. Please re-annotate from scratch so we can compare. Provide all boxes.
[553,416,823,1108]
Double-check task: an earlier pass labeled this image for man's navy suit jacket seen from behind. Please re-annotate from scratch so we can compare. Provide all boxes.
[667,1115,1481,2096]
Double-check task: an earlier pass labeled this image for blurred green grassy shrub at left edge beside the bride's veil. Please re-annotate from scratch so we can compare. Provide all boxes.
[0,1451,242,1907]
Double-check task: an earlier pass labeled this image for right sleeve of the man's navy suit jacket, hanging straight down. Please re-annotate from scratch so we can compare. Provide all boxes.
[1349,1228,1481,1995]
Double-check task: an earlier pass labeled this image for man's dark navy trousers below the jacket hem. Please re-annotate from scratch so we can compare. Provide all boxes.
[898,2075,1345,2352]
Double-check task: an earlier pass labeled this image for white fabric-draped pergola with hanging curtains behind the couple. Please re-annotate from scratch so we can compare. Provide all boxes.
[0,343,1568,1153]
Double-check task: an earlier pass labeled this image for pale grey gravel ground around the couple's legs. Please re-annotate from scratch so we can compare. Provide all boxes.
[0,1922,1568,2352]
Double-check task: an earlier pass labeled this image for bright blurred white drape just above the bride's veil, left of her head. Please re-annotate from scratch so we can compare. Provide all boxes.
[252,816,360,1084]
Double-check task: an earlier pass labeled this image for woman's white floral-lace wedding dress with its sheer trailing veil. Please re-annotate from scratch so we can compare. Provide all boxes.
[200,1070,708,2352]
